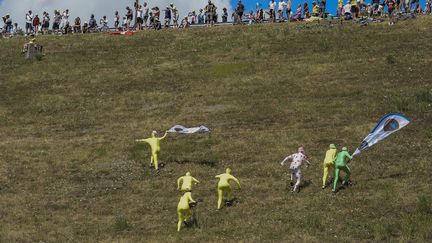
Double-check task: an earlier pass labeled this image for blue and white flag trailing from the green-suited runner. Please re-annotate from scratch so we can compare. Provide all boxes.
[353,114,410,156]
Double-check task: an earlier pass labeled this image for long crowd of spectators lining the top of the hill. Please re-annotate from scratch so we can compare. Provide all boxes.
[1,0,432,35]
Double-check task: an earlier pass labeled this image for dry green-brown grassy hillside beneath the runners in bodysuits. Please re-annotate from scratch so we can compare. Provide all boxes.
[0,17,432,242]
